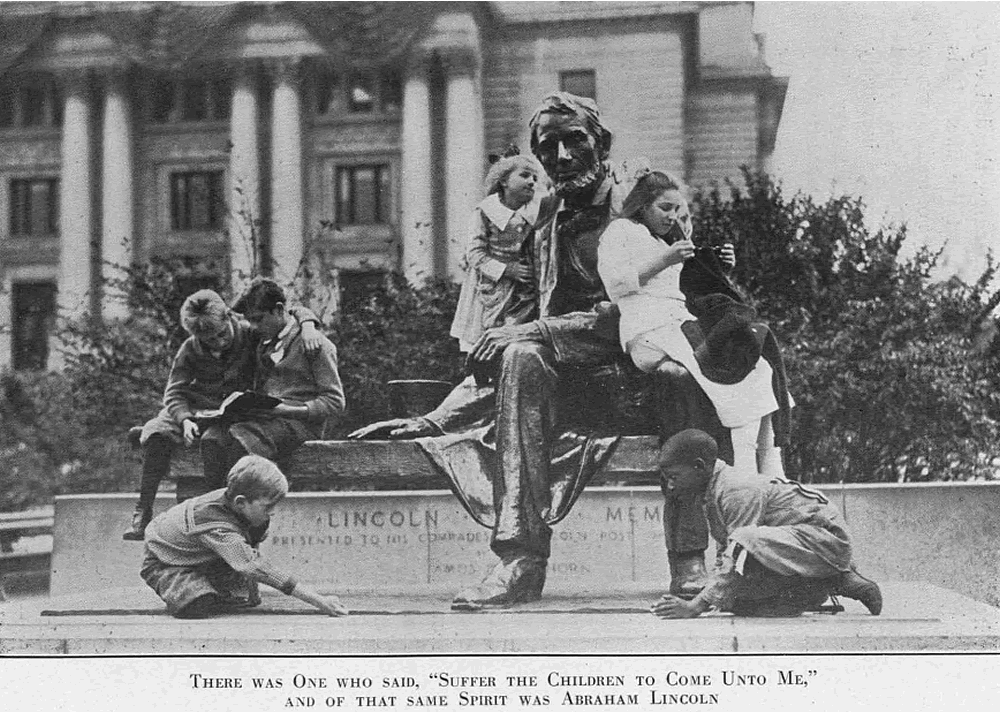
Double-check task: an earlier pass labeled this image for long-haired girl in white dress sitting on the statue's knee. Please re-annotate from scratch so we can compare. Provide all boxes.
[597,171,782,475]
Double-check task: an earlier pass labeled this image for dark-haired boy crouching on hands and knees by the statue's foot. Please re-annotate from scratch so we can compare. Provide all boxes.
[650,430,882,618]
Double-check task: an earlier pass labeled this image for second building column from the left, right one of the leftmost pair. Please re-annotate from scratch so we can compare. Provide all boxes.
[101,71,134,319]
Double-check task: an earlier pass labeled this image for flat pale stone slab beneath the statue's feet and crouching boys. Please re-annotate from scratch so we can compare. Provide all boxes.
[0,582,1000,655]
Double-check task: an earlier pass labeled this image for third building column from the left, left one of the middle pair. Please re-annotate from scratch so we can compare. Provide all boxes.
[229,65,261,294]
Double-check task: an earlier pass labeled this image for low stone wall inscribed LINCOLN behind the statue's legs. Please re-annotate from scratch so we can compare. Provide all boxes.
[51,483,1000,605]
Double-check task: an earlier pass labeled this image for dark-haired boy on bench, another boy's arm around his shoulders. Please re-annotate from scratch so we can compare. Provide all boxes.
[201,279,344,485]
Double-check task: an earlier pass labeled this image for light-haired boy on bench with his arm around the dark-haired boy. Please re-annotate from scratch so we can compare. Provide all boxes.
[123,289,322,541]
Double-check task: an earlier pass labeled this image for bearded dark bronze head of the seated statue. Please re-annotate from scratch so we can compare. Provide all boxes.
[528,92,611,198]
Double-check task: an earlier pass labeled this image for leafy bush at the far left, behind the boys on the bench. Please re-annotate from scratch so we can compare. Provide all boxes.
[0,260,223,510]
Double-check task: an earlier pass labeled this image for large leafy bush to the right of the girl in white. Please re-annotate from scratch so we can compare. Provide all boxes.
[695,171,1000,482]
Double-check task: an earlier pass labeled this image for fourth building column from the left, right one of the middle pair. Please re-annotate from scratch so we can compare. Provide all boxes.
[270,58,304,287]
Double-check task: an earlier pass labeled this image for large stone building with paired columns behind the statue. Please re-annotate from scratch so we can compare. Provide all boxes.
[0,2,787,369]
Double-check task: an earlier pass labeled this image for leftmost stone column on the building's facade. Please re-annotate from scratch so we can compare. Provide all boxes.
[57,72,93,317]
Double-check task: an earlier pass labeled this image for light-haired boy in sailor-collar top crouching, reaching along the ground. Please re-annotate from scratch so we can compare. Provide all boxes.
[140,455,347,618]
